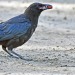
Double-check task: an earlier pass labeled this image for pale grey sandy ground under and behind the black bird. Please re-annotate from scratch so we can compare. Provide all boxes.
[0,0,75,75]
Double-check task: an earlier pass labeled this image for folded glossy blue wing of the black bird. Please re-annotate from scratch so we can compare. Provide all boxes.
[0,15,31,41]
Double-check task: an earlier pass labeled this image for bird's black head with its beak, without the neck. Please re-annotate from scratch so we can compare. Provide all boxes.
[25,3,53,15]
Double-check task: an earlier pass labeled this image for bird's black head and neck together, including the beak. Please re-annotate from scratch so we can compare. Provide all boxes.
[25,3,52,24]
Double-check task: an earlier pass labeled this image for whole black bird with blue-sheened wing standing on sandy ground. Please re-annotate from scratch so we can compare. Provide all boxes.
[0,3,52,59]
